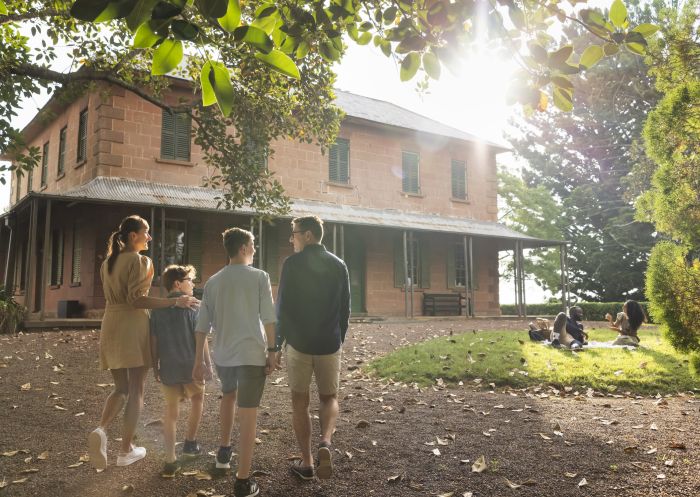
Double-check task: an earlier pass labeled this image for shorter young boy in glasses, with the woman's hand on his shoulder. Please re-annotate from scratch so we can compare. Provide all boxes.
[151,265,211,478]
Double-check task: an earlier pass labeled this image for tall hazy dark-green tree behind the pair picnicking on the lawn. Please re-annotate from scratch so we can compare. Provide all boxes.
[502,2,662,301]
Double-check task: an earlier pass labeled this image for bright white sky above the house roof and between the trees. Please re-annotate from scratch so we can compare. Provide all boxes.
[0,31,544,304]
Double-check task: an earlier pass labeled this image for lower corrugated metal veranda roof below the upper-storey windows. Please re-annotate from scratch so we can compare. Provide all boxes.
[46,177,562,248]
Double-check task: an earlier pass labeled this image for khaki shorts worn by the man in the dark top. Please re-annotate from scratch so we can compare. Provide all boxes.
[287,344,343,395]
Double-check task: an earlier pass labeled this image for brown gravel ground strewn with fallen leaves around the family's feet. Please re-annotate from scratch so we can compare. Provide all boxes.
[0,320,700,497]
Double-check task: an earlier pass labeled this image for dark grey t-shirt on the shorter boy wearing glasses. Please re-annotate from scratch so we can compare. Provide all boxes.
[151,293,197,385]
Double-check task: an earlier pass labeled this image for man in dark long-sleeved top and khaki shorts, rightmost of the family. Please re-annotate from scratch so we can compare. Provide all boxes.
[276,216,350,480]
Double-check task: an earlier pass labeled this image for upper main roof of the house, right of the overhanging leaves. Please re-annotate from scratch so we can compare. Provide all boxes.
[335,90,510,151]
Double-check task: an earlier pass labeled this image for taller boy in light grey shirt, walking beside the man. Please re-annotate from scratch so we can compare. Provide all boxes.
[192,228,276,497]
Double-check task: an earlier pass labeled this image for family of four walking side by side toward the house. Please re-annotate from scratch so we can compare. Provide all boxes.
[88,216,350,497]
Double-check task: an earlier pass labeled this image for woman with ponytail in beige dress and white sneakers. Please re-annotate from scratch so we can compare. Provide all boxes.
[88,216,199,469]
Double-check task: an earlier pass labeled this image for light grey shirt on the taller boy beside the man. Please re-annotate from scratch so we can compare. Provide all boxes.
[197,264,277,367]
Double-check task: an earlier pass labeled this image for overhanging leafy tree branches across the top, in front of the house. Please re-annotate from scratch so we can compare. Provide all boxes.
[0,0,656,211]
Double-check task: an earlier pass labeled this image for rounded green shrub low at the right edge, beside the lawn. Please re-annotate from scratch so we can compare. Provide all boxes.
[646,242,700,352]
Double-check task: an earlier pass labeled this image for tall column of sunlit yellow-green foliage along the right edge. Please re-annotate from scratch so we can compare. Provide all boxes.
[637,0,700,362]
